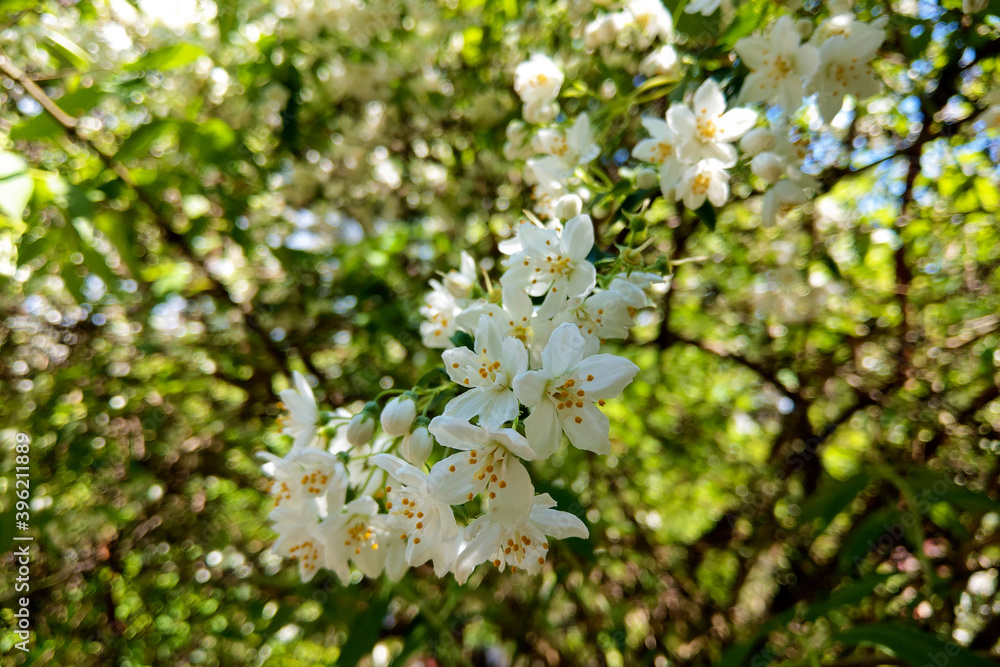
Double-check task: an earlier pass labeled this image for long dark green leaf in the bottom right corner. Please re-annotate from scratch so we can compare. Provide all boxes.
[835,622,995,667]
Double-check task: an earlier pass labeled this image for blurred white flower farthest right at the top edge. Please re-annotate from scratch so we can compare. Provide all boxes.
[808,23,884,123]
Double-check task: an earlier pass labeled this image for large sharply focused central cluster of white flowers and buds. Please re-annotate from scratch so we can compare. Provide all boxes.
[263,215,661,584]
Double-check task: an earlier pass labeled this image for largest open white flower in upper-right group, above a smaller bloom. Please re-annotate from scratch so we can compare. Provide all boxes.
[667,79,757,167]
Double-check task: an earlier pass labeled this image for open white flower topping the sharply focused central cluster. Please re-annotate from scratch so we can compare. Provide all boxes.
[500,215,597,316]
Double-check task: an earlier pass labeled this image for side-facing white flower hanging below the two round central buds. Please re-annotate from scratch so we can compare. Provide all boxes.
[372,454,472,577]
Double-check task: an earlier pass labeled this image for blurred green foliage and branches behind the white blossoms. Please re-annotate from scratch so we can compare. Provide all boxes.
[0,0,1000,667]
